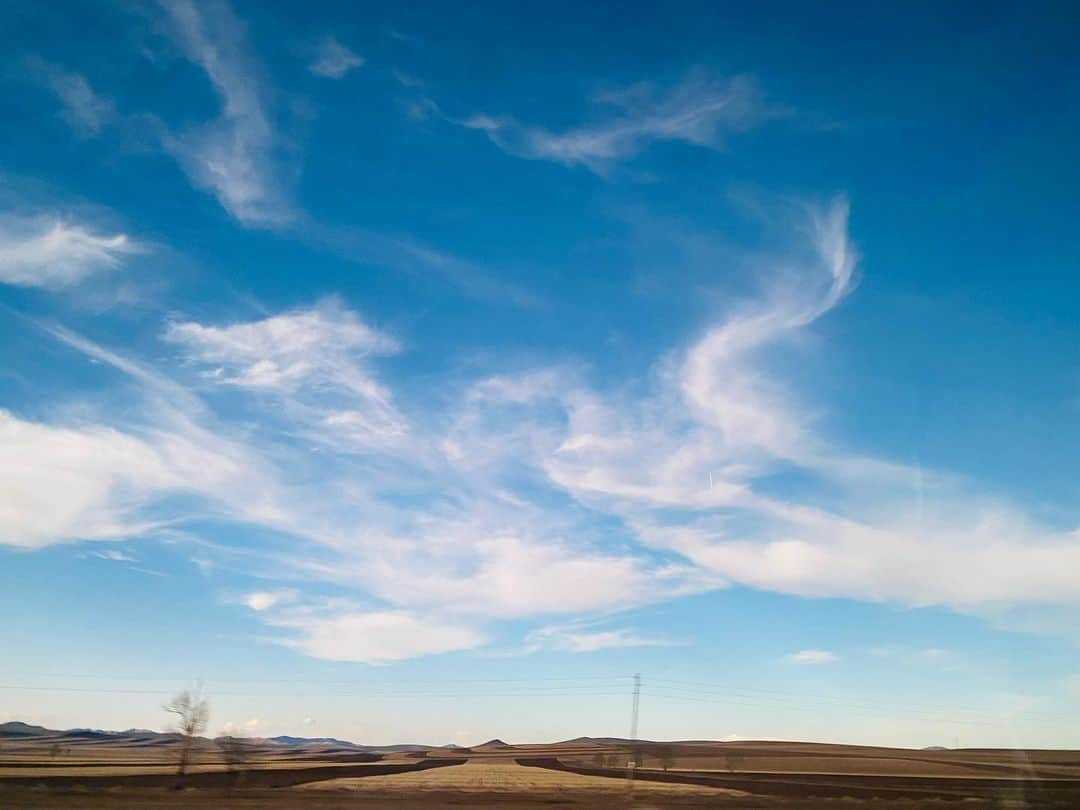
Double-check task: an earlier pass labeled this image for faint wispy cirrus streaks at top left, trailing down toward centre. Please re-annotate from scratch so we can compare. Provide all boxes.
[9,0,522,307]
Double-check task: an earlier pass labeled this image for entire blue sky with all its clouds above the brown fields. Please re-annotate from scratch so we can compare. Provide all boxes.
[0,2,1080,746]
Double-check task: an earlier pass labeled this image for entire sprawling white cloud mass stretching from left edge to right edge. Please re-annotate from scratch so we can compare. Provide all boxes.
[8,193,1080,661]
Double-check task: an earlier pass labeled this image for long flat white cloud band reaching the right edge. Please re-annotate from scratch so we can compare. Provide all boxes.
[635,502,1080,612]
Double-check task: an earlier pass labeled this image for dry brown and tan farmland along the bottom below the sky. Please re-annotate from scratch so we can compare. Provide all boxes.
[0,732,1080,810]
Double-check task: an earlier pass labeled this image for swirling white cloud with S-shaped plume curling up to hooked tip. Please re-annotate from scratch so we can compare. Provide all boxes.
[455,200,866,516]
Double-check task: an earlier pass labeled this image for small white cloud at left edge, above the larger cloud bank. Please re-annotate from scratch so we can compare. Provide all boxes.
[0,215,143,288]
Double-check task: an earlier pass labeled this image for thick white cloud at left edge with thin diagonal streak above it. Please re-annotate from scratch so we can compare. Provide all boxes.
[0,328,285,548]
